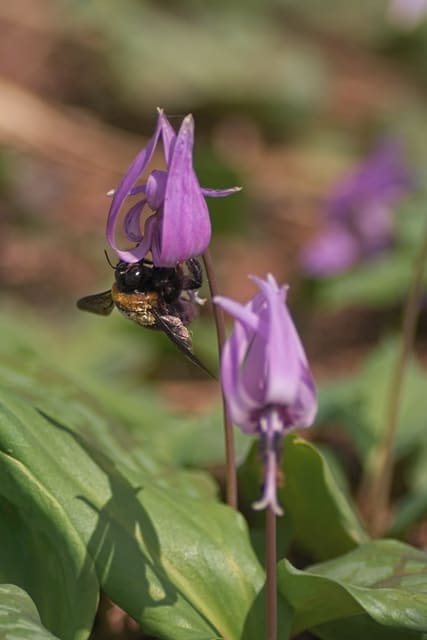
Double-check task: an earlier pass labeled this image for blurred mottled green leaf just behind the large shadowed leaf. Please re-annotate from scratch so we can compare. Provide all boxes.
[0,336,217,499]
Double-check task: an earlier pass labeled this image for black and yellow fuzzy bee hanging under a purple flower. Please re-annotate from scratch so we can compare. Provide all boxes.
[77,258,213,377]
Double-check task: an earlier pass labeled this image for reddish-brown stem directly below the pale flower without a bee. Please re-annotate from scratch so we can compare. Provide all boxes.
[265,506,277,640]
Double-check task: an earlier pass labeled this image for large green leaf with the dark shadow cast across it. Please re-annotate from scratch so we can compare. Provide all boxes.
[0,392,264,640]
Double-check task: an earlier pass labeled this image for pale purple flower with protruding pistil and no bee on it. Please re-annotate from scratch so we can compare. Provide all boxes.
[214,274,317,514]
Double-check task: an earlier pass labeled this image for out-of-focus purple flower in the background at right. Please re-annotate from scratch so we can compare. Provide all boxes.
[301,142,415,278]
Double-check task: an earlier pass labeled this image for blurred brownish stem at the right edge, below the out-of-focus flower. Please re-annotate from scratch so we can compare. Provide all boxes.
[361,218,427,537]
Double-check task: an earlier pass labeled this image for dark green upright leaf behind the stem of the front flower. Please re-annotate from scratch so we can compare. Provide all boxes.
[240,435,368,560]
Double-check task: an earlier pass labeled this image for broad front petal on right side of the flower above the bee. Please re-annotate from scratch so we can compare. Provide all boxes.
[153,115,211,267]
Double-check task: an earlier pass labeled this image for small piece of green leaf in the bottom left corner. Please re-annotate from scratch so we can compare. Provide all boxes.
[0,584,58,640]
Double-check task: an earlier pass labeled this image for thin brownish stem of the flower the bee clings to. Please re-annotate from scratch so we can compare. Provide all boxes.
[203,249,237,509]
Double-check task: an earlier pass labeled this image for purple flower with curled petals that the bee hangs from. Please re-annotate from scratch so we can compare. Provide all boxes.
[107,109,240,267]
